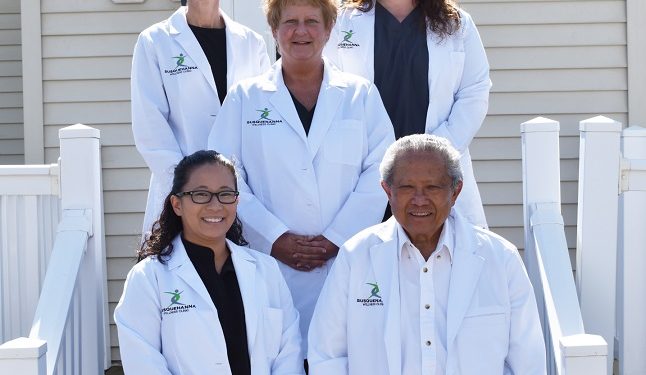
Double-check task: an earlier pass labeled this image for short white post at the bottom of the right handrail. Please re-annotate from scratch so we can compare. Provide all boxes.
[559,334,608,375]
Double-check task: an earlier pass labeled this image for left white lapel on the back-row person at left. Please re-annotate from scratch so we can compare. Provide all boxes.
[170,7,217,93]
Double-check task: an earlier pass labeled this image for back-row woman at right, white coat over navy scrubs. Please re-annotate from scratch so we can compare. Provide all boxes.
[323,0,491,227]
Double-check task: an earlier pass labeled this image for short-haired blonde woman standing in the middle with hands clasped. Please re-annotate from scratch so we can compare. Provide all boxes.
[209,0,394,356]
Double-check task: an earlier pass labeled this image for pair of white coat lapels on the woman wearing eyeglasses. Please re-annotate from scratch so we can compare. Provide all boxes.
[166,236,260,349]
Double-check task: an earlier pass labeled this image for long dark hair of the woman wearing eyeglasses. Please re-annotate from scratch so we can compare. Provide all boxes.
[137,150,248,263]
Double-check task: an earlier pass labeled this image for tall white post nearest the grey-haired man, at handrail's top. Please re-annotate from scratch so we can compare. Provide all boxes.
[520,117,561,327]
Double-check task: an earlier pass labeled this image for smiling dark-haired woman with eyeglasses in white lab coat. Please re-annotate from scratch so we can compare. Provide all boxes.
[114,151,303,375]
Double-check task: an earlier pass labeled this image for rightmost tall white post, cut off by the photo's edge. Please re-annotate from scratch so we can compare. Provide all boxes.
[617,126,646,375]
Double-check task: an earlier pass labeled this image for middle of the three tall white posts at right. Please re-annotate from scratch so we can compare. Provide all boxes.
[576,116,621,374]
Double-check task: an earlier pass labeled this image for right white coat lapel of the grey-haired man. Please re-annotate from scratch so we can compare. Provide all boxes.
[446,214,485,350]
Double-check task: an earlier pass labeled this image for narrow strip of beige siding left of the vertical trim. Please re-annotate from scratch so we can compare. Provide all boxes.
[0,0,24,164]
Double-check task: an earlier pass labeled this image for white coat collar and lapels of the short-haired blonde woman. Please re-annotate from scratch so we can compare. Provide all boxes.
[260,58,348,159]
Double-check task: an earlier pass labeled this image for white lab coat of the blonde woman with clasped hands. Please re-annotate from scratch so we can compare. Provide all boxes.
[209,60,394,350]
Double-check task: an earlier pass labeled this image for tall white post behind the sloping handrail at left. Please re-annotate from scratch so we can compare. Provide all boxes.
[30,124,110,374]
